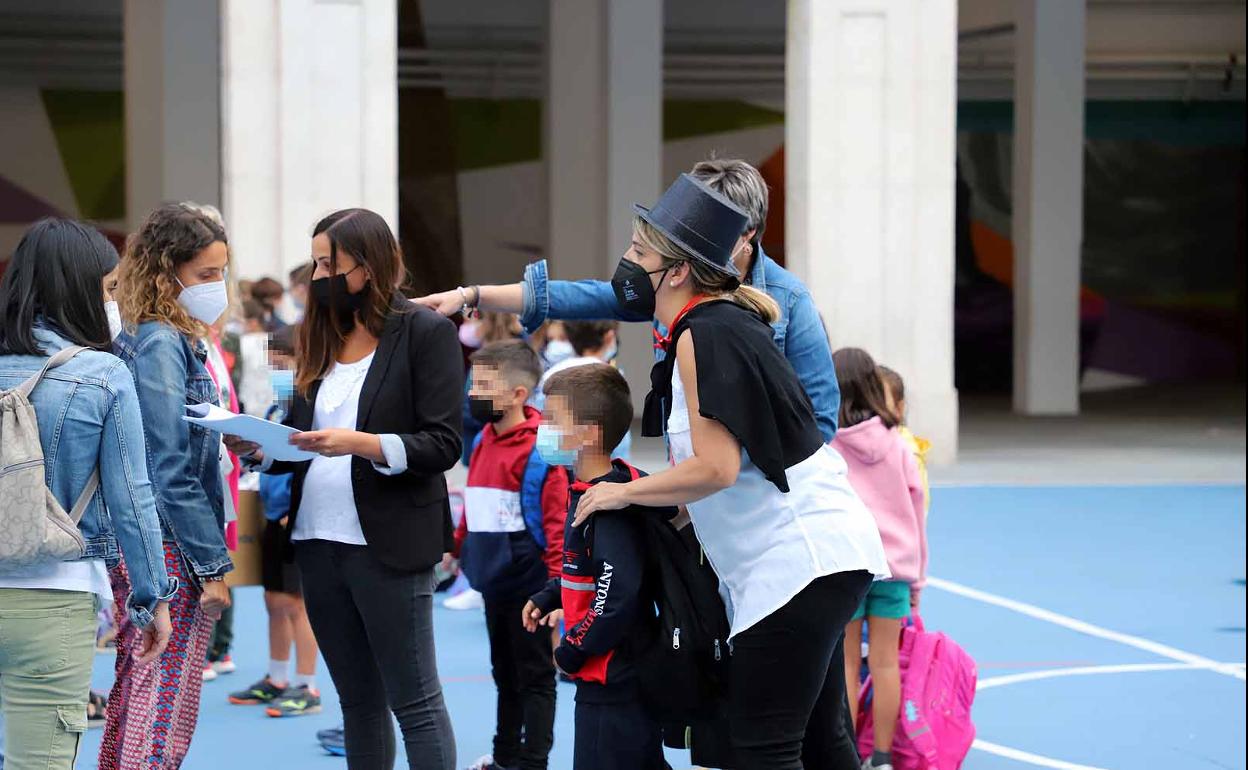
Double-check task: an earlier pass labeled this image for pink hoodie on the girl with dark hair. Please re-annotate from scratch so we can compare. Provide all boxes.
[832,417,927,593]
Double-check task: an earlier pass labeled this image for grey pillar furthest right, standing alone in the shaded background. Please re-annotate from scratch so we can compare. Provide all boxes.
[1013,0,1087,414]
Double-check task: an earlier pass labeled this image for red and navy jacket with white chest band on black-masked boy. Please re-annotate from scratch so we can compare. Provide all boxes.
[456,407,568,599]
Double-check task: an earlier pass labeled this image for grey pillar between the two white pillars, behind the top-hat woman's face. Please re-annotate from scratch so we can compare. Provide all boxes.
[544,0,666,407]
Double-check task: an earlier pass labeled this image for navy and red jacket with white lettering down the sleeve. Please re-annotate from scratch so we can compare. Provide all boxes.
[533,461,675,699]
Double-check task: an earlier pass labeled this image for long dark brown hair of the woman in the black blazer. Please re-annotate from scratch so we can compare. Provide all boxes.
[295,208,407,396]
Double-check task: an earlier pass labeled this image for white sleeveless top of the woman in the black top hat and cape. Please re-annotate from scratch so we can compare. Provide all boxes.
[668,359,889,640]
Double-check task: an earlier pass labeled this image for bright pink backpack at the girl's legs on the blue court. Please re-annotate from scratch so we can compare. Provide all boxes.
[857,615,977,770]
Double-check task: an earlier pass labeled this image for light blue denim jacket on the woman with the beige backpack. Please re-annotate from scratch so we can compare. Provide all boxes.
[0,328,177,626]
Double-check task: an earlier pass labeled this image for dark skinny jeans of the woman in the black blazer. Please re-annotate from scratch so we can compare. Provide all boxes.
[295,540,459,770]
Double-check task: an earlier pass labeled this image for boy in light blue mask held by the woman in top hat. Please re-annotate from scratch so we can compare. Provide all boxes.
[524,364,676,770]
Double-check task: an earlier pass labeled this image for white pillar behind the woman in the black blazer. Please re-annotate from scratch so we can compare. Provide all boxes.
[220,0,398,280]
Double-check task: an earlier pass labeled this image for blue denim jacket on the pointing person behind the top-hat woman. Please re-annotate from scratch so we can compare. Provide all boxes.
[520,248,841,442]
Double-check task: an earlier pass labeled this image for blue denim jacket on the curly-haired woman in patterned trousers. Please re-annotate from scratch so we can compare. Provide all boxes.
[116,321,233,578]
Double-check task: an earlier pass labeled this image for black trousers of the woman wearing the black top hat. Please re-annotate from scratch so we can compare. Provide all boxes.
[729,570,871,770]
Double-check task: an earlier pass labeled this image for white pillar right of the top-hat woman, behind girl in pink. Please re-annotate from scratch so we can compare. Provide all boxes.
[785,0,957,462]
